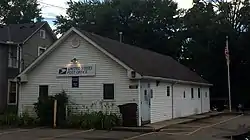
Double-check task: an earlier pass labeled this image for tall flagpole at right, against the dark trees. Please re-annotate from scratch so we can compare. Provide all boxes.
[226,36,232,112]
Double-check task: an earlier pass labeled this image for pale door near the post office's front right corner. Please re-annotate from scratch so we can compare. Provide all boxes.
[141,84,151,124]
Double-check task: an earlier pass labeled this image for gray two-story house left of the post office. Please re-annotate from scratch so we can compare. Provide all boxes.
[0,22,57,113]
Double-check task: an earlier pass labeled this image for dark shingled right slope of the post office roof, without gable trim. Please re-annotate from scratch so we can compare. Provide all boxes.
[81,31,209,83]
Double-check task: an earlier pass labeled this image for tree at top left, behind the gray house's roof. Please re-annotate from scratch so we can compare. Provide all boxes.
[0,0,42,24]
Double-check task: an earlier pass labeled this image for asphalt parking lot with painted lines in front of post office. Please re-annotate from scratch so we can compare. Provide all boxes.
[0,115,250,140]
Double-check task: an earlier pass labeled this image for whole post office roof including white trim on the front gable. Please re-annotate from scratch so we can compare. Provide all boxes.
[17,28,211,85]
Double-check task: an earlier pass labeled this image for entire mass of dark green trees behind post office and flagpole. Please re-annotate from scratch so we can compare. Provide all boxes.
[55,0,250,106]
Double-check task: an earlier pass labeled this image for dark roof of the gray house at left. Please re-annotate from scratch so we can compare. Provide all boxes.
[0,21,56,44]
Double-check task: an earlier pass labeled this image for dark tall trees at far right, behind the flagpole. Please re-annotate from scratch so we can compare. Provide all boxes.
[182,0,250,105]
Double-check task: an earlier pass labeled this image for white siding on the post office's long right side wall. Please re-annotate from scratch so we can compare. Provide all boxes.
[150,82,210,123]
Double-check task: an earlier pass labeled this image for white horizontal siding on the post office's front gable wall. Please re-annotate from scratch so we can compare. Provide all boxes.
[19,34,139,115]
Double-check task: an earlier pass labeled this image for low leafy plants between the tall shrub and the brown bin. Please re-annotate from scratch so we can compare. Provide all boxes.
[67,111,121,129]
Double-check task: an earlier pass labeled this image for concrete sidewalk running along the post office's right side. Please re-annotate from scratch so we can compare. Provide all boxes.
[113,112,231,132]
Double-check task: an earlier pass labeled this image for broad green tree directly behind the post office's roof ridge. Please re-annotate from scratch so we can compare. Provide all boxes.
[55,0,181,58]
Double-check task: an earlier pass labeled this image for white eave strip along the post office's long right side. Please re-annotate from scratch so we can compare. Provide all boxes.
[142,76,213,86]
